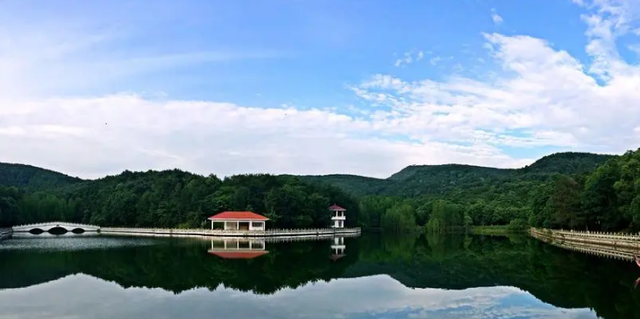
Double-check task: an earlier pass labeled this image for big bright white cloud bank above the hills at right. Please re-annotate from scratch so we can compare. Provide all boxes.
[361,24,640,156]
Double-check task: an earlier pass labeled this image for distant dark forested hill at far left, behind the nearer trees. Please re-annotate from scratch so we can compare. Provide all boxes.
[0,163,82,191]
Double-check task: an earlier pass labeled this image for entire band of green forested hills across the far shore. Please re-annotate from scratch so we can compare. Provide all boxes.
[0,150,640,232]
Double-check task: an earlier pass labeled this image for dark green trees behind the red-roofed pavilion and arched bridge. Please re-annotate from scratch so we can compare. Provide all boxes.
[0,170,359,228]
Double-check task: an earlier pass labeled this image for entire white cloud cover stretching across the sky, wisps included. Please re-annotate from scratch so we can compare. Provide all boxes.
[0,0,640,177]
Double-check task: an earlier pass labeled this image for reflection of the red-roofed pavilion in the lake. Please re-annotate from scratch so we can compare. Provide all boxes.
[207,238,269,259]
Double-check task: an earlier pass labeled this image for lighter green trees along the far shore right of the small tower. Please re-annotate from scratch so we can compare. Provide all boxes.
[359,149,640,232]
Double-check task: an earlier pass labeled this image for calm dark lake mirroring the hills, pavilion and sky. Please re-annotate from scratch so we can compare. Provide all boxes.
[0,234,640,319]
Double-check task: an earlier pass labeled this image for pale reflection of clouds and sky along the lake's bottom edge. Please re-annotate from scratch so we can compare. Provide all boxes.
[0,275,597,319]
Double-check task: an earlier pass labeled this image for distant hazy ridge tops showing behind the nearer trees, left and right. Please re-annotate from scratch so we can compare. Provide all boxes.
[0,152,618,196]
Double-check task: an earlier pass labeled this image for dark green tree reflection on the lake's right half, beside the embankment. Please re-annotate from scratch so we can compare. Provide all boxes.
[352,236,640,319]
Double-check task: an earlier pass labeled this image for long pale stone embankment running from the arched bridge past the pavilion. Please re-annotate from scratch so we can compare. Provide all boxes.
[100,227,361,238]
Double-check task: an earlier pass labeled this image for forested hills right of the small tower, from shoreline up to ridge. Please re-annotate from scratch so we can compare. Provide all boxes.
[302,150,640,232]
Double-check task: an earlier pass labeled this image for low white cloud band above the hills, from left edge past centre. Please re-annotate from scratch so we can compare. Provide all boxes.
[0,95,520,177]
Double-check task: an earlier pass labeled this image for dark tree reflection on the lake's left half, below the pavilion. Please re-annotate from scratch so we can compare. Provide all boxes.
[0,239,357,294]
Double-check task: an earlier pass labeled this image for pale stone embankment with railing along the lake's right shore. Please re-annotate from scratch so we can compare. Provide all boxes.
[529,228,640,260]
